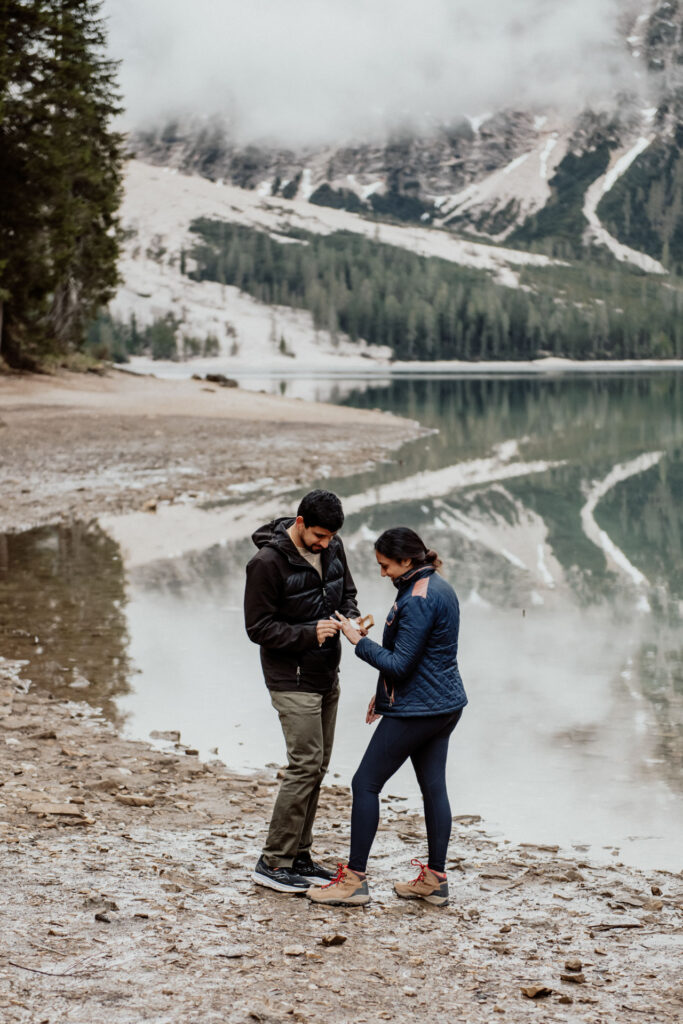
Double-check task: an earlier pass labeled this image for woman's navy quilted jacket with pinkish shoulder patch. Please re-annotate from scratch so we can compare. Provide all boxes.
[355,565,467,717]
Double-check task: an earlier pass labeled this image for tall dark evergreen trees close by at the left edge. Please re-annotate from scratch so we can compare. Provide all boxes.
[0,0,123,369]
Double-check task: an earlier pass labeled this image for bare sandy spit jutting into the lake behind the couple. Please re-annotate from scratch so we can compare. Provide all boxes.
[0,371,422,531]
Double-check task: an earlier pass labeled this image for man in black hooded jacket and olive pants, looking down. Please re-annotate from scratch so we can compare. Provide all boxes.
[245,490,358,893]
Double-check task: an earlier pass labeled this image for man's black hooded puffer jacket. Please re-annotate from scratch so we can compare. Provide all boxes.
[245,516,358,693]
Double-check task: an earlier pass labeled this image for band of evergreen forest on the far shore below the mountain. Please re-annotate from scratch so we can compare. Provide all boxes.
[190,219,683,360]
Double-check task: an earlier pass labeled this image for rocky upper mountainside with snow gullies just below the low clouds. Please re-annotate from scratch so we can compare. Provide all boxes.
[132,0,683,269]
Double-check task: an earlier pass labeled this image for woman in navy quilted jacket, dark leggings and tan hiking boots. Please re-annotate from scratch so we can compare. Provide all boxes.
[308,526,467,906]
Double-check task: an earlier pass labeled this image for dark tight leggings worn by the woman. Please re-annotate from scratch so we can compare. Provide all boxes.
[348,710,462,871]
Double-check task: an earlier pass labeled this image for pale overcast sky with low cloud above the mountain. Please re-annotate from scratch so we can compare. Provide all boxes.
[104,0,645,143]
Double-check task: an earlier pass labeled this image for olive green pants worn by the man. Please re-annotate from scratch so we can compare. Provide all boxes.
[263,683,339,867]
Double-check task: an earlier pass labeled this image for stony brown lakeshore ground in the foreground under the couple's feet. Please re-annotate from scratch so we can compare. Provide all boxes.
[0,659,683,1024]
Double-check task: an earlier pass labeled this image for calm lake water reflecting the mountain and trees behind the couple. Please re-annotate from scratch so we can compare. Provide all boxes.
[0,374,683,869]
